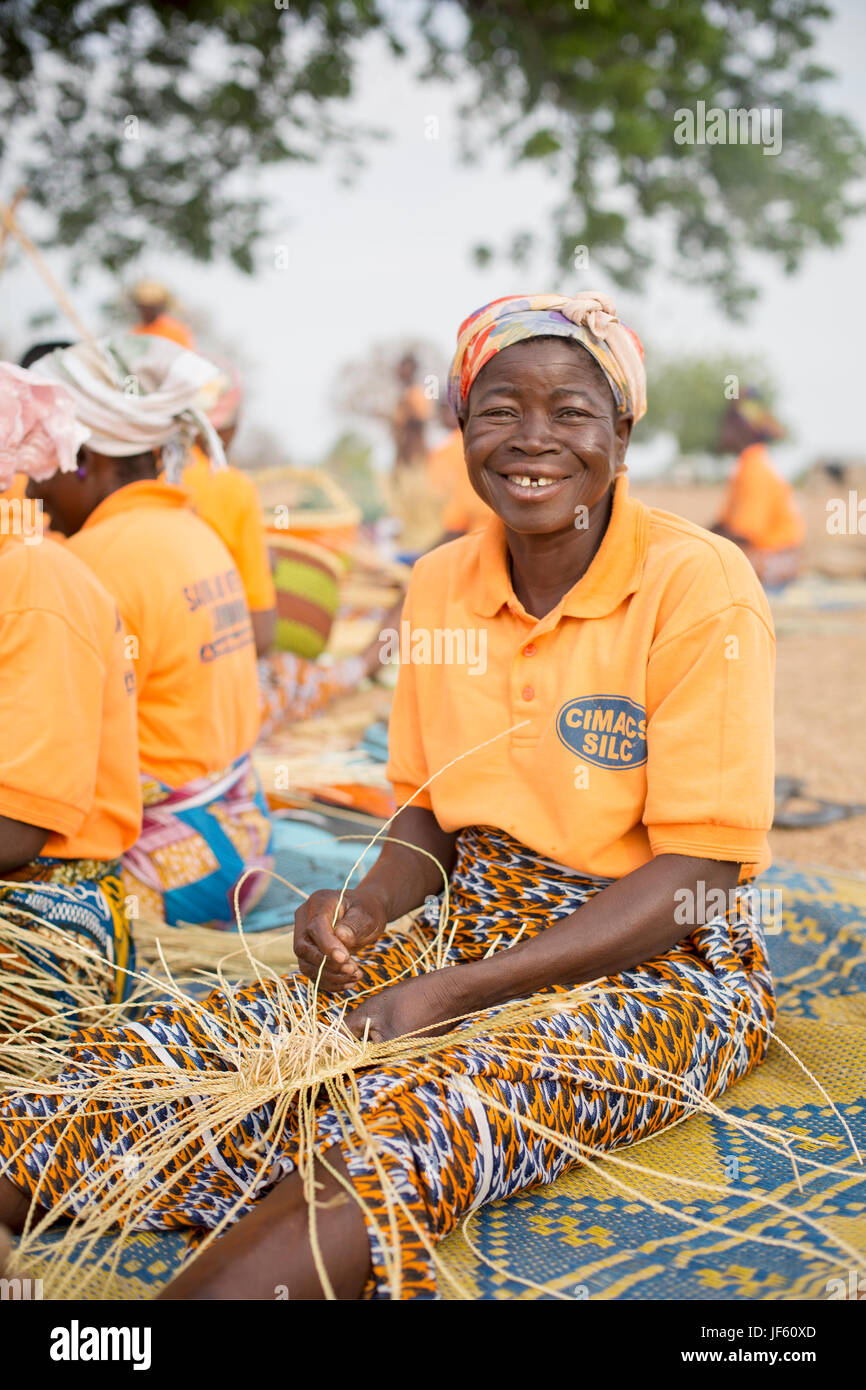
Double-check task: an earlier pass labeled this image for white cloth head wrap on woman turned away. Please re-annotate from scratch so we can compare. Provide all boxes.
[28,334,225,481]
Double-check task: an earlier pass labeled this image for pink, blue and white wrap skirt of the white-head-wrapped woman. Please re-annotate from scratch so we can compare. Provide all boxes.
[122,753,274,930]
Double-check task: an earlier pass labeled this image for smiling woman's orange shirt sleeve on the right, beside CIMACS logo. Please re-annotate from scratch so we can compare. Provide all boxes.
[644,603,774,866]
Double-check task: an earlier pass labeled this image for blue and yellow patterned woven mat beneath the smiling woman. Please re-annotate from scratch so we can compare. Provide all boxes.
[22,865,866,1300]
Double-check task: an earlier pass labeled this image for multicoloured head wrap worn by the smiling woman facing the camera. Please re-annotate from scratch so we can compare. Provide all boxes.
[448,292,646,421]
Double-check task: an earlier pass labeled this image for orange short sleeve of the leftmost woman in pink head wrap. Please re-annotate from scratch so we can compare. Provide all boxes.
[0,609,106,835]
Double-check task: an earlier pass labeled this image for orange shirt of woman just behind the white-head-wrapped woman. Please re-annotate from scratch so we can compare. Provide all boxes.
[181,445,277,613]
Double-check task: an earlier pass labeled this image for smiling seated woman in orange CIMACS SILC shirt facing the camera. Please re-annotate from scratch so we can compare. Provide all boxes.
[0,295,774,1300]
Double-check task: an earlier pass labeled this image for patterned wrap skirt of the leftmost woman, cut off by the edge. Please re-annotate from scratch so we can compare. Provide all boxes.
[0,855,135,1026]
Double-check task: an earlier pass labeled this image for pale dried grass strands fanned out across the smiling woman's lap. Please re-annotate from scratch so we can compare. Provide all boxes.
[3,726,860,1298]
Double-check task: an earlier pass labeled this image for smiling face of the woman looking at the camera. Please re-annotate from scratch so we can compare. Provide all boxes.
[463,338,631,534]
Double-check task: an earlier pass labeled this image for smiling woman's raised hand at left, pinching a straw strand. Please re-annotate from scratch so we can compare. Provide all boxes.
[295,885,388,994]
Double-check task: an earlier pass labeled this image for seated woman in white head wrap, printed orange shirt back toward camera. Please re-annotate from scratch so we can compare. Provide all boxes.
[23,335,271,924]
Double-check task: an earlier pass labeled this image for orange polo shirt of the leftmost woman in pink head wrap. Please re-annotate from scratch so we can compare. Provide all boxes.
[0,535,142,859]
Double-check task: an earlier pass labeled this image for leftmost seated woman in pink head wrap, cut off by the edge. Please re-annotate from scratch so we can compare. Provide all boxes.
[0,363,142,1030]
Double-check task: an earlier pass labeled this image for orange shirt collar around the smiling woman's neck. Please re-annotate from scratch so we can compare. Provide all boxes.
[471,474,649,620]
